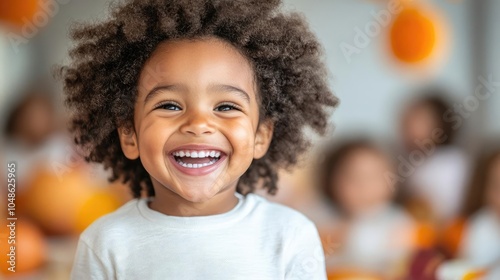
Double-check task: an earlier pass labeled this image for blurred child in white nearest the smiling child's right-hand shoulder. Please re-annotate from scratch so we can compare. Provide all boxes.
[322,140,414,279]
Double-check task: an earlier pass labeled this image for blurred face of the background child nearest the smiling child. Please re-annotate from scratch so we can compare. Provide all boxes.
[332,149,392,215]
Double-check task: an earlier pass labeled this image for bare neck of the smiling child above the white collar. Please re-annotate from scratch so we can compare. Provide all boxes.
[148,184,238,217]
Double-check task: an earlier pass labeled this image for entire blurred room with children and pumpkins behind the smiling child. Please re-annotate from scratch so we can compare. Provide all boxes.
[0,0,500,280]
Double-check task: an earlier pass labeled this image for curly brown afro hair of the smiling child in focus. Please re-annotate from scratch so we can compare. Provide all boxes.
[56,0,338,197]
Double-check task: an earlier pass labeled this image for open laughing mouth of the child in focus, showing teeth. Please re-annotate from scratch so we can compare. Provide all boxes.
[170,149,226,175]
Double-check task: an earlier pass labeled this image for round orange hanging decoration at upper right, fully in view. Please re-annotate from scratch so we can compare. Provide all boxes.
[389,7,437,63]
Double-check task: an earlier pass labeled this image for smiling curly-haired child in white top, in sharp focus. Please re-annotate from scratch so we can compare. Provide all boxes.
[58,0,337,280]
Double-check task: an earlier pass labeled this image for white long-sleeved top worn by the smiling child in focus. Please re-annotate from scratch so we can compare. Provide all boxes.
[71,193,326,280]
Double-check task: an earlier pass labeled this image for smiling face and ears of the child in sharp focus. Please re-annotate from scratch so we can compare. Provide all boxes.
[120,38,272,202]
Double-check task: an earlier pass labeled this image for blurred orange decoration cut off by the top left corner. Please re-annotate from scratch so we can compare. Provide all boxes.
[0,0,40,28]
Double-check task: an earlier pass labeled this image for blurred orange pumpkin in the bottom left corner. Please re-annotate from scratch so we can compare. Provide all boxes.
[0,217,47,275]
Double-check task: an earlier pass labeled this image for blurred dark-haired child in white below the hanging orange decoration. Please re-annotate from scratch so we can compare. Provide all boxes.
[398,89,469,230]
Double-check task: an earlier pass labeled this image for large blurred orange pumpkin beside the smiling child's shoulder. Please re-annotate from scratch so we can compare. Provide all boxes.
[20,168,123,234]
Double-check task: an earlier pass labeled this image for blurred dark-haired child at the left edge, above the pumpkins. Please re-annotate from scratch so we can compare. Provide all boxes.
[3,85,68,189]
